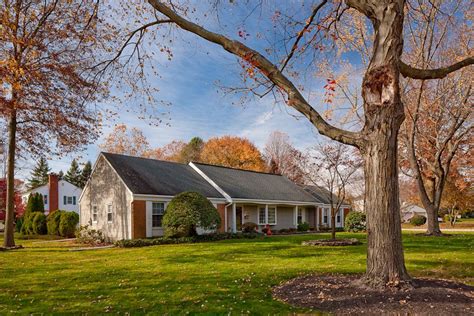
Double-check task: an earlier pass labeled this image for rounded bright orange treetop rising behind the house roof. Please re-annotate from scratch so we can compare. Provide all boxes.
[200,136,265,171]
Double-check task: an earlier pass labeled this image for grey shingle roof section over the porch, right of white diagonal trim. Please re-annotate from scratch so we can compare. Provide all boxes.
[194,163,317,203]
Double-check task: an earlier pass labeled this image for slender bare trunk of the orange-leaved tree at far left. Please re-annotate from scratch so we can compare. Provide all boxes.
[3,109,17,248]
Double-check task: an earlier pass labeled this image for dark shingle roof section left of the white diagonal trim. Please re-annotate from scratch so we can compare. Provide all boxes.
[102,153,223,198]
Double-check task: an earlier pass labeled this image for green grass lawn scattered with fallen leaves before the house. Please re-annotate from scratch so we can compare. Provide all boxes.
[0,233,474,315]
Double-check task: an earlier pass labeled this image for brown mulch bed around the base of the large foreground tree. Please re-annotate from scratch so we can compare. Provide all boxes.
[273,275,474,315]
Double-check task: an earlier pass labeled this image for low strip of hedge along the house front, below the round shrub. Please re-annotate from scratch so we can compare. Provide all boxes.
[115,233,262,248]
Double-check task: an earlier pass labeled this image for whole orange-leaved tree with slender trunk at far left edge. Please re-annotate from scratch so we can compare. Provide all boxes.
[0,0,111,247]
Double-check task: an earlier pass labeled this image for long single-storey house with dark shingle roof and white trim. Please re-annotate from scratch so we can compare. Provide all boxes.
[79,153,349,240]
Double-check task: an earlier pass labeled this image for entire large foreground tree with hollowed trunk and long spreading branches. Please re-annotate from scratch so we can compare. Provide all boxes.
[103,0,474,287]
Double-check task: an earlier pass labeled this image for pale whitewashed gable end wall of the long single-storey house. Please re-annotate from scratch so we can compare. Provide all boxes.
[79,157,132,240]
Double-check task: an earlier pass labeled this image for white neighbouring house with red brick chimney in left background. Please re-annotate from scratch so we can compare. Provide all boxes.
[22,173,82,214]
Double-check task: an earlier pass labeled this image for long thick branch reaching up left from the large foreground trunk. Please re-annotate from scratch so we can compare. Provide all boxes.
[148,0,361,147]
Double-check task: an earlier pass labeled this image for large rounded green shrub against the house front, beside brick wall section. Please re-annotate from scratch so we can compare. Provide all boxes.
[163,192,221,237]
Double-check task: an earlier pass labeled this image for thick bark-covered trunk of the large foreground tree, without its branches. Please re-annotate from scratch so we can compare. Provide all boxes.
[351,0,410,287]
